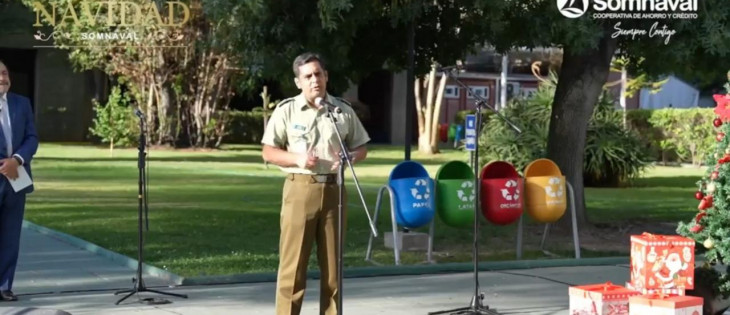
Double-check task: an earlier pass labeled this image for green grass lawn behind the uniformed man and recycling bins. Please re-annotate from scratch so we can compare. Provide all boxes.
[26,143,703,276]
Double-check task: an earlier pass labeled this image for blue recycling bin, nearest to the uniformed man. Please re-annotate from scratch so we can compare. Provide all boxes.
[388,161,435,228]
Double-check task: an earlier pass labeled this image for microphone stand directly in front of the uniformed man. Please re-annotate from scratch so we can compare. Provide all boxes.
[322,102,378,315]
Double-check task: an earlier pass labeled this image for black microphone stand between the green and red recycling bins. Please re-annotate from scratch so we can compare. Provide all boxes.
[428,67,522,315]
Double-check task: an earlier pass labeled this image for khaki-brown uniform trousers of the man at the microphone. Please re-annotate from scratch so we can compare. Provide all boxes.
[276,174,347,315]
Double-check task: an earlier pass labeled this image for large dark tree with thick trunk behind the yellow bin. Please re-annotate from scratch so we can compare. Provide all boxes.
[474,0,730,224]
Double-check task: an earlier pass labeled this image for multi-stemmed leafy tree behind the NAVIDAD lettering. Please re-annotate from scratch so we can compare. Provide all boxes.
[23,0,237,147]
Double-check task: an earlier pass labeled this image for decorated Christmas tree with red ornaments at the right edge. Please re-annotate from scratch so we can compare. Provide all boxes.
[677,72,730,298]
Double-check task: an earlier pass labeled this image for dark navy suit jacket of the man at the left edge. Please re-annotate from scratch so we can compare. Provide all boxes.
[0,93,38,193]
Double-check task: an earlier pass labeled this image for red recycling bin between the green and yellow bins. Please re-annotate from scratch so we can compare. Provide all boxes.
[480,161,523,225]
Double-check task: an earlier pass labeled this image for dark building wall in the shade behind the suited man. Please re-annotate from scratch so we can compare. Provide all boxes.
[0,2,107,142]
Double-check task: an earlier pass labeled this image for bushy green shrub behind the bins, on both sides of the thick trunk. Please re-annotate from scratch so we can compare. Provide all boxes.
[479,72,647,187]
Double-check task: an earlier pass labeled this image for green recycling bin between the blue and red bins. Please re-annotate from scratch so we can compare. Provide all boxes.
[436,161,476,227]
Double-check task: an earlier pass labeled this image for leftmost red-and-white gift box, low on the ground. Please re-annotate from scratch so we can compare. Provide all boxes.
[568,282,641,315]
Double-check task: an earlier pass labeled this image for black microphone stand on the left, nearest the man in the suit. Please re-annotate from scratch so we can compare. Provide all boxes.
[114,109,188,305]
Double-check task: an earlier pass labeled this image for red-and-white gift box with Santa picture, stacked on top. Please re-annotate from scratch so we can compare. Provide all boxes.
[631,233,695,293]
